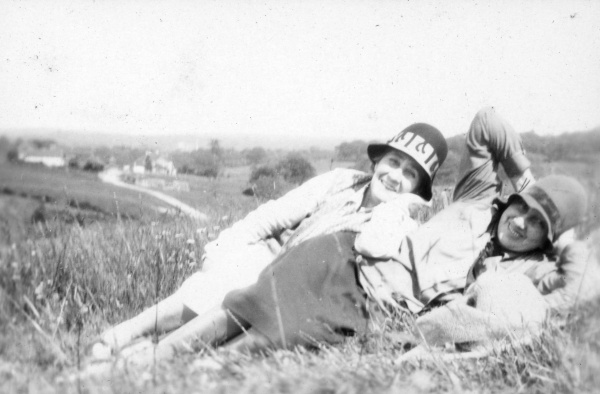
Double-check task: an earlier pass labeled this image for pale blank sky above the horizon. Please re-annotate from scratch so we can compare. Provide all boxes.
[0,0,600,149]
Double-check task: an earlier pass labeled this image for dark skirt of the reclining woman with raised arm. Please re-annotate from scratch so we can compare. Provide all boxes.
[223,232,369,348]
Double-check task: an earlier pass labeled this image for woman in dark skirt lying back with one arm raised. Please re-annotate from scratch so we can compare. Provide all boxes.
[91,108,586,363]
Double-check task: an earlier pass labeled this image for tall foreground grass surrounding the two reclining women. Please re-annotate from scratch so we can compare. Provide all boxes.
[0,184,600,393]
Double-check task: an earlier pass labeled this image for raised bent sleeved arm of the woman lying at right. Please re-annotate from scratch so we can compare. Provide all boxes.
[454,107,534,201]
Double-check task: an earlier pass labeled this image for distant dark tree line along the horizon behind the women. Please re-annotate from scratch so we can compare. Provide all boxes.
[0,127,600,198]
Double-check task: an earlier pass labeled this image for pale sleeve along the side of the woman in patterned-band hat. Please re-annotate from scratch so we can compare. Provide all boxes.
[204,170,342,259]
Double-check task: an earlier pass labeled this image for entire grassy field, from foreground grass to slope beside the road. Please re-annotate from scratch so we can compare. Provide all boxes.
[0,155,600,393]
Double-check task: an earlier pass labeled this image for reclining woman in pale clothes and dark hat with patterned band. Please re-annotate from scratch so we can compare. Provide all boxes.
[93,123,448,358]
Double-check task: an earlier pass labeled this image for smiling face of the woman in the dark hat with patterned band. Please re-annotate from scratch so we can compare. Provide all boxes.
[363,149,425,207]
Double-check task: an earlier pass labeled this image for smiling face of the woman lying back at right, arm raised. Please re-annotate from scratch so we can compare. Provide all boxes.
[498,198,548,252]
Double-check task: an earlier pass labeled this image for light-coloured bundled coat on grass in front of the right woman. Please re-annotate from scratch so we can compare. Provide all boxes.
[397,272,549,362]
